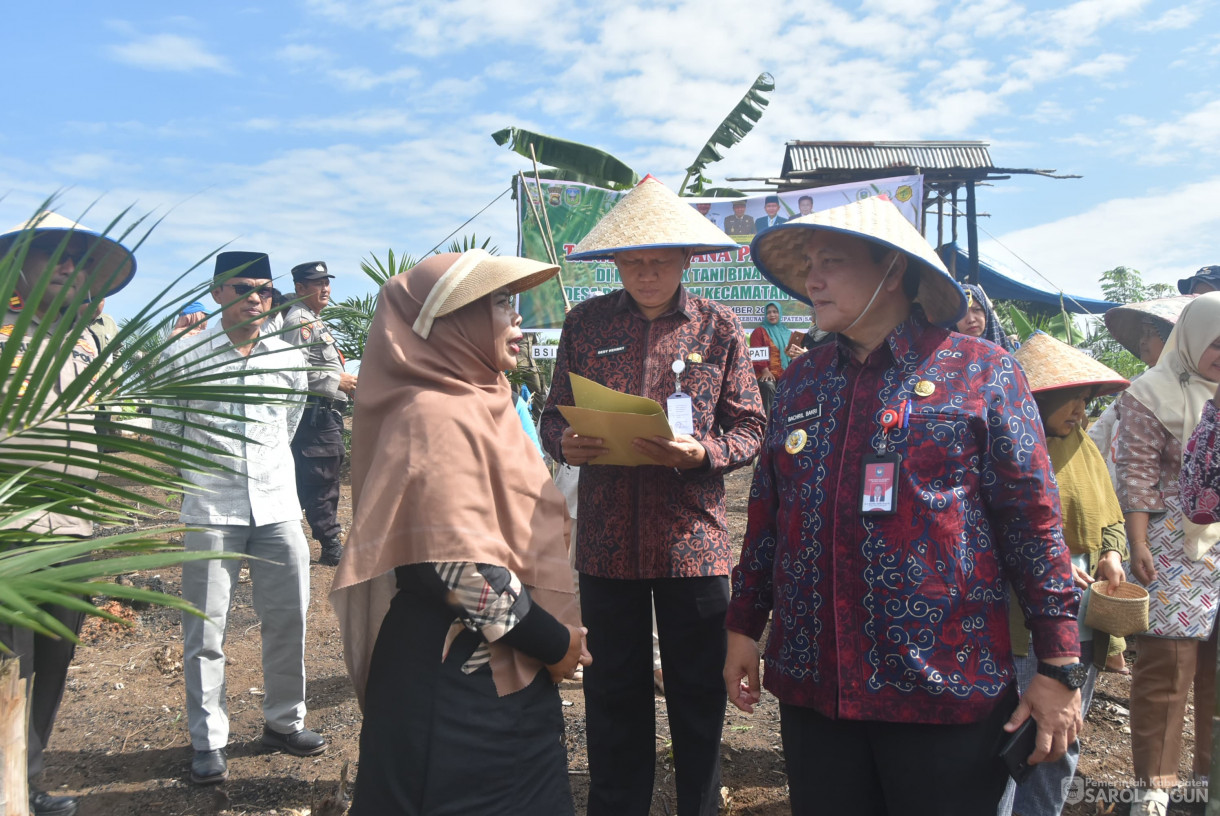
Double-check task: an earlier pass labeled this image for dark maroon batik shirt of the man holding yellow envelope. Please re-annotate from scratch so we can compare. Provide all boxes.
[539,288,766,578]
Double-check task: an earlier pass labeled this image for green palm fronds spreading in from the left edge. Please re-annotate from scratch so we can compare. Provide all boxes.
[0,196,314,637]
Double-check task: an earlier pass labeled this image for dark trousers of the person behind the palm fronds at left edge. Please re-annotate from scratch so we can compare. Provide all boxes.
[0,597,84,779]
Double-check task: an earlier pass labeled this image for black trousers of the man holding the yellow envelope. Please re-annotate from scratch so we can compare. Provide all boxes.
[581,573,728,816]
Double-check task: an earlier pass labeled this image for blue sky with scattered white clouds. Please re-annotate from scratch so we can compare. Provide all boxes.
[0,0,1220,317]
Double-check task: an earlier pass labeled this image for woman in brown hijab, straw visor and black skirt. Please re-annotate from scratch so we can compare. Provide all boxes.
[331,250,590,816]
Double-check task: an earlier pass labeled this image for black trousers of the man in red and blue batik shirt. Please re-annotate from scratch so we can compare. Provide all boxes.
[780,687,1017,816]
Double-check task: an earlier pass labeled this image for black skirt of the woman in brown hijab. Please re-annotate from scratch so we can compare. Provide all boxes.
[349,575,575,816]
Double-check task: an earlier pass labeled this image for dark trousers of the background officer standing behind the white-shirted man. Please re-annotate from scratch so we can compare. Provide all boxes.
[292,404,343,542]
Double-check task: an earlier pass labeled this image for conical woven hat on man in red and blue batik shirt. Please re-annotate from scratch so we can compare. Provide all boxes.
[750,196,966,327]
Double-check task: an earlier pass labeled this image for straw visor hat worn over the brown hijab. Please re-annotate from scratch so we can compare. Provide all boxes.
[407,249,559,339]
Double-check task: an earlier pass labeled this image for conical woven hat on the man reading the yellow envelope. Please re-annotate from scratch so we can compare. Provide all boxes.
[567,176,737,261]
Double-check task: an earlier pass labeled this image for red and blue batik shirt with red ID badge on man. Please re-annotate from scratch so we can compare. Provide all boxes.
[727,316,1078,723]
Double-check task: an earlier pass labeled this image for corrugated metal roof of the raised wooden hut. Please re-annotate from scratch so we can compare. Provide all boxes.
[780,141,993,177]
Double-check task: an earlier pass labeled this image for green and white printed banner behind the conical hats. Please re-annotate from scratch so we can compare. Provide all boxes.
[516,176,924,331]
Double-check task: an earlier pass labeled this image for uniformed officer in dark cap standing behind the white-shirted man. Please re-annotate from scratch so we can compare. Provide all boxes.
[283,261,356,567]
